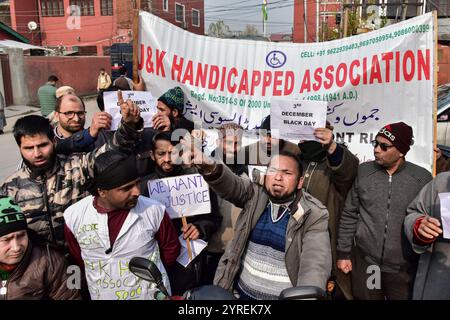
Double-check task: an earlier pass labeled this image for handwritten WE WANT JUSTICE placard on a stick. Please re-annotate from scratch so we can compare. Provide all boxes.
[147,174,211,219]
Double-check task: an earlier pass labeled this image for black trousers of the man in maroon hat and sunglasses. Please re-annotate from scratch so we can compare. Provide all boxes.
[351,247,415,300]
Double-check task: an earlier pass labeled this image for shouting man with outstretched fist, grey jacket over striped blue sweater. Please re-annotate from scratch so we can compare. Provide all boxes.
[173,135,331,299]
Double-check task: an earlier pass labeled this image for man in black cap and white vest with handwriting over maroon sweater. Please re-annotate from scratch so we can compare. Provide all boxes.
[64,150,180,300]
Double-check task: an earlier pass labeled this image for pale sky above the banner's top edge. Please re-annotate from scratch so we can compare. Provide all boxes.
[204,0,294,34]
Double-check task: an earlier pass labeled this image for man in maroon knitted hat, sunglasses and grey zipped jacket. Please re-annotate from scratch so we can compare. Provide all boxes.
[337,122,432,300]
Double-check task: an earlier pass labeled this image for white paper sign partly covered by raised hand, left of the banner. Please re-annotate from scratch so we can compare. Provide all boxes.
[103,91,157,130]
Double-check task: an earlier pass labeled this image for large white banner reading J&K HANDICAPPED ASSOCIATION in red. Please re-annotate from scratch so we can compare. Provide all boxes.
[139,12,435,170]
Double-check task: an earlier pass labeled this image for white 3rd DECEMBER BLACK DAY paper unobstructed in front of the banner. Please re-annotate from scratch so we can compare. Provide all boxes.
[270,99,327,143]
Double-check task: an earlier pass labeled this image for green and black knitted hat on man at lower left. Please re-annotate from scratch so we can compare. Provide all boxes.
[0,196,27,237]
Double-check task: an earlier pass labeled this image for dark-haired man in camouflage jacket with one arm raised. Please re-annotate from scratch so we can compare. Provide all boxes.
[0,95,143,246]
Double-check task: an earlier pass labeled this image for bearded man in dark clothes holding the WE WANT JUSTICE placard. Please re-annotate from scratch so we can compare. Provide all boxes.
[141,132,221,295]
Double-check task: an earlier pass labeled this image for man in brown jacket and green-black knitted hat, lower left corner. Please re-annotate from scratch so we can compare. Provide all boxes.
[0,196,81,300]
